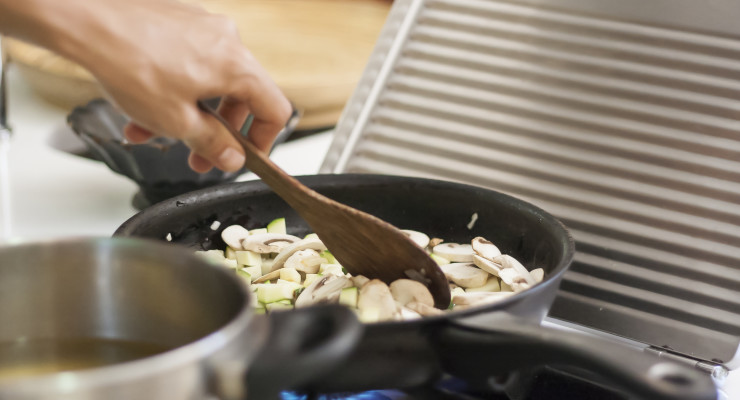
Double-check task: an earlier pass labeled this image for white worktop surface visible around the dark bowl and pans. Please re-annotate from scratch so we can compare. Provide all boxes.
[0,66,740,400]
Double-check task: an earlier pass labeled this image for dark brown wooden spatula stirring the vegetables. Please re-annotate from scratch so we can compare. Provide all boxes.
[199,102,450,309]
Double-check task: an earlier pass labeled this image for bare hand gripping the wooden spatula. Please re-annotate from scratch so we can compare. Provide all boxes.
[63,0,291,172]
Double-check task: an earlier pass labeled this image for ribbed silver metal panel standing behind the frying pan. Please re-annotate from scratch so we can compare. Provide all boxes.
[322,0,740,362]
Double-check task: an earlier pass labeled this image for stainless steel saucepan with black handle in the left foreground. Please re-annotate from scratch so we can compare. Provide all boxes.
[0,238,362,400]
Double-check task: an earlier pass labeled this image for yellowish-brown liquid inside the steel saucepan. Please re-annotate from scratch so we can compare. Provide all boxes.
[0,338,170,381]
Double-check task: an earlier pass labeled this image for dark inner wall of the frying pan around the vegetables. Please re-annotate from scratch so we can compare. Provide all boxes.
[115,174,573,275]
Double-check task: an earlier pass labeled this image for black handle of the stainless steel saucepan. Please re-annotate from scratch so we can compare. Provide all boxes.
[246,305,362,400]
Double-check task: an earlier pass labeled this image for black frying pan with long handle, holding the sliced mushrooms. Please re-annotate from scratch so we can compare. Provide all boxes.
[115,175,716,400]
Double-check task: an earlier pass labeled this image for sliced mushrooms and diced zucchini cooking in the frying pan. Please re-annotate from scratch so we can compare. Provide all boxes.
[198,218,544,323]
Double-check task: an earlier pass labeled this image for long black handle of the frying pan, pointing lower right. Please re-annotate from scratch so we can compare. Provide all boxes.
[436,318,717,400]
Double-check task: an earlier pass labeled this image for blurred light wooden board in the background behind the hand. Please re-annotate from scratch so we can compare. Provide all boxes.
[5,0,391,129]
